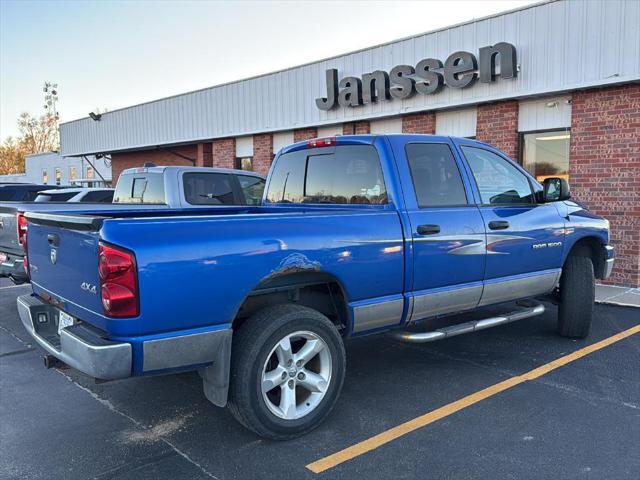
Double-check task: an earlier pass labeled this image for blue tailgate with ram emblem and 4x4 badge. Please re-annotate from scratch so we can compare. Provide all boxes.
[26,213,103,327]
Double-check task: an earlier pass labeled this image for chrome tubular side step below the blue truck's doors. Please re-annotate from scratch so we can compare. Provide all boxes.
[390,301,545,343]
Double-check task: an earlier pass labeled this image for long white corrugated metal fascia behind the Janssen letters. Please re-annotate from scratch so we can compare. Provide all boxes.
[61,0,640,155]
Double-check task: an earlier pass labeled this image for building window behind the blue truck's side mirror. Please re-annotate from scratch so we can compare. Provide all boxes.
[520,130,571,182]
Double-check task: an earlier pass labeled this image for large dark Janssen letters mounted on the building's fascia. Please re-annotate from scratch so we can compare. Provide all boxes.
[316,42,518,110]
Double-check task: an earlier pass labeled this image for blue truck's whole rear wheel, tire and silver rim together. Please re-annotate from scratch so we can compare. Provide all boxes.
[228,304,346,440]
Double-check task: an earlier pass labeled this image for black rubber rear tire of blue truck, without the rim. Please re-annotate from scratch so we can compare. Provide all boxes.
[227,304,346,440]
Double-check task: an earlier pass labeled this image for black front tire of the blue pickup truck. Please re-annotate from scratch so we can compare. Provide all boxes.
[558,256,595,338]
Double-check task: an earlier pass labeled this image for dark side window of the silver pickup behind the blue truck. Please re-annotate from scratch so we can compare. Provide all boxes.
[182,173,238,205]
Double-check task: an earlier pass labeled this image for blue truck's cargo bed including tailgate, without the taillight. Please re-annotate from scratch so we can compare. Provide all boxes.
[27,205,404,339]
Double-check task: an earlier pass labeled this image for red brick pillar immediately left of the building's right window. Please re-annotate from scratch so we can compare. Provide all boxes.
[476,101,518,160]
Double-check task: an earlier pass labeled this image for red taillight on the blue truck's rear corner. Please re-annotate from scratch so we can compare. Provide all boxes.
[98,243,140,317]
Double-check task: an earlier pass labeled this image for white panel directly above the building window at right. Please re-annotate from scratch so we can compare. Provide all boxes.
[518,96,571,132]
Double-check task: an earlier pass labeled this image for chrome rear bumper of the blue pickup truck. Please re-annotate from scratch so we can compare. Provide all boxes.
[17,295,132,380]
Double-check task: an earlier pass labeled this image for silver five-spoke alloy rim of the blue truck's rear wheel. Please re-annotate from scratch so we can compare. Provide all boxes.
[261,331,331,420]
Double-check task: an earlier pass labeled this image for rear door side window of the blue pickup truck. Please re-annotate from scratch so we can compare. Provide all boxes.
[406,143,467,208]
